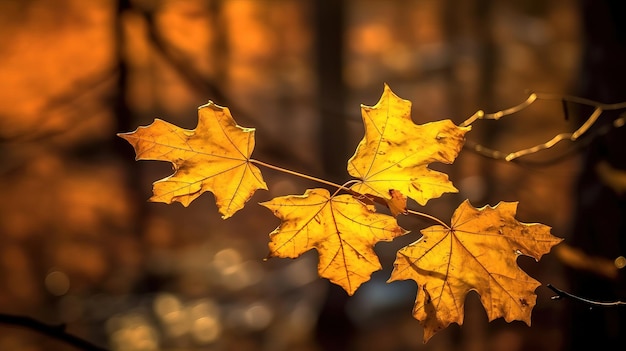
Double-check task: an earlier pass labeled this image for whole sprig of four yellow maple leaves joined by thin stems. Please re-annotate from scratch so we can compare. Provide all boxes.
[119,85,561,341]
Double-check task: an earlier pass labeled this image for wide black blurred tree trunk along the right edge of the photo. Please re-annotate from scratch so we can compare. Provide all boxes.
[565,0,626,350]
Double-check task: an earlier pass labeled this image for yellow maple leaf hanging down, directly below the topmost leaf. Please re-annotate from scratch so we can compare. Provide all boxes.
[261,189,407,295]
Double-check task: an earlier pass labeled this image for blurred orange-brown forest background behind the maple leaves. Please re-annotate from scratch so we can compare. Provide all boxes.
[0,0,626,351]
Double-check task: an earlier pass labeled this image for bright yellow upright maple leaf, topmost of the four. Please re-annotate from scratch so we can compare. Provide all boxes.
[348,84,470,205]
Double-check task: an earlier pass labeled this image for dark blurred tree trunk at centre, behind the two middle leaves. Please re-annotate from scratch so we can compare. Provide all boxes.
[312,0,353,351]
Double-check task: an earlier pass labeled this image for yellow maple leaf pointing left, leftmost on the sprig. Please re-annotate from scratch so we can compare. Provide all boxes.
[118,101,267,218]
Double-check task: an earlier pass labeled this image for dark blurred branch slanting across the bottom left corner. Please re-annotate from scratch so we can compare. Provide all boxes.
[0,313,107,351]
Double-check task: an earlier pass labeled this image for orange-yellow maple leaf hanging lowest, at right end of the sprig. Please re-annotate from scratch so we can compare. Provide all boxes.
[389,200,562,342]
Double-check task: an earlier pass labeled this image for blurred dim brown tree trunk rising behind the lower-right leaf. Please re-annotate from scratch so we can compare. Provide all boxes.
[443,0,497,350]
